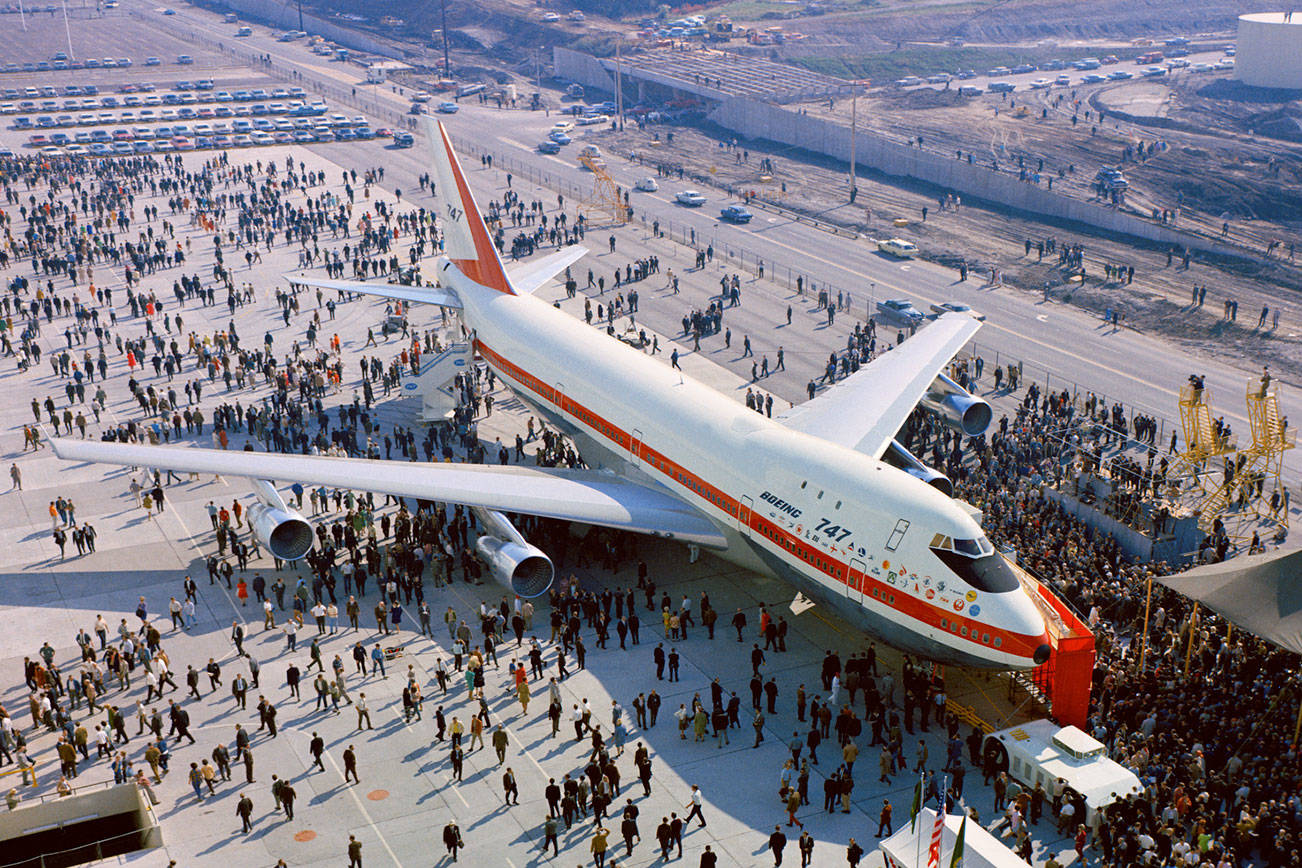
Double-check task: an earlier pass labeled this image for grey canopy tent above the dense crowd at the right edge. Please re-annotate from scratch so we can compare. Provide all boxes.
[1157,549,1302,653]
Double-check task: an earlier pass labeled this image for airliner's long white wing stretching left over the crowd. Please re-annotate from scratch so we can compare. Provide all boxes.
[51,439,727,548]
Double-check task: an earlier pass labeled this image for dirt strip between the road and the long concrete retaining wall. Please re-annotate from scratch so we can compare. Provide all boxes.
[603,119,1302,380]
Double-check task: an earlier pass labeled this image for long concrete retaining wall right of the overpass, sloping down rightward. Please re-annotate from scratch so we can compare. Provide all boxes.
[710,98,1242,256]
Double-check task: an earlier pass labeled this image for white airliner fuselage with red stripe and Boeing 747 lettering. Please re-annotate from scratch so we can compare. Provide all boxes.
[439,260,1048,669]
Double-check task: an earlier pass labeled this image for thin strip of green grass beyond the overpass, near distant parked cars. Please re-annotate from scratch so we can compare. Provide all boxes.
[788,46,1152,83]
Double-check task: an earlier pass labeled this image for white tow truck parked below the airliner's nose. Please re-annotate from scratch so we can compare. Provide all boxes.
[982,720,1142,829]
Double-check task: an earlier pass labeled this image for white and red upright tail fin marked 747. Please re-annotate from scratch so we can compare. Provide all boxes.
[426,118,516,295]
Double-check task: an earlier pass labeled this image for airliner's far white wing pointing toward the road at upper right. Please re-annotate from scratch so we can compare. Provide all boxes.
[780,314,980,458]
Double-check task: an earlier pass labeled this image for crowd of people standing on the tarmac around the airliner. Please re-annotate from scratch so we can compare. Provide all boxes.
[0,139,1302,868]
